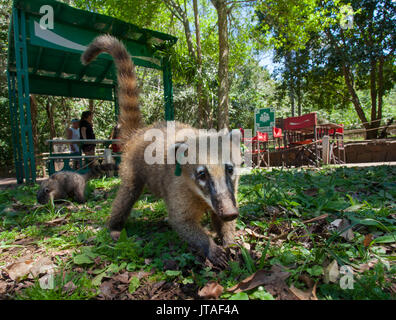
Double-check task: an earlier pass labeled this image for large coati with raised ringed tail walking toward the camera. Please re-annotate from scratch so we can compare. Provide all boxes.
[81,35,240,267]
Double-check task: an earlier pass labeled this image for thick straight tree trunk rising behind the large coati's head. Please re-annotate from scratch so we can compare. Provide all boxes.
[212,0,229,129]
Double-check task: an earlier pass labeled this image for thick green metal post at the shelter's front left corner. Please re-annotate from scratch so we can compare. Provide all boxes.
[13,8,36,183]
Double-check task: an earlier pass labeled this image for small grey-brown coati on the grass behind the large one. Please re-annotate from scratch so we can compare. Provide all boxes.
[37,164,117,204]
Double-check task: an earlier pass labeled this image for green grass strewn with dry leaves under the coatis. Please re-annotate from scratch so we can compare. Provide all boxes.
[0,166,396,300]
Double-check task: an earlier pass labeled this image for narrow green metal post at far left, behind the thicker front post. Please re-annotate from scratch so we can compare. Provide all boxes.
[7,70,23,184]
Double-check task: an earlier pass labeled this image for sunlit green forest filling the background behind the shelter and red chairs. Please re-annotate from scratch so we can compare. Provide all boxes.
[0,0,396,172]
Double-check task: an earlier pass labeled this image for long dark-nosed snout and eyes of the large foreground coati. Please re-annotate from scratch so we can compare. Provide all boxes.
[193,164,239,221]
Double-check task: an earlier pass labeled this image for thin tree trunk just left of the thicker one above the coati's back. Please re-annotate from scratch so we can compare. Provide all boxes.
[193,0,208,128]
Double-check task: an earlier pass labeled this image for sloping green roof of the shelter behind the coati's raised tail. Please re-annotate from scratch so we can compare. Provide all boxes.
[8,0,177,100]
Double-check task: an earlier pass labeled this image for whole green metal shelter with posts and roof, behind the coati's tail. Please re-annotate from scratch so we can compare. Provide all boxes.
[7,0,177,183]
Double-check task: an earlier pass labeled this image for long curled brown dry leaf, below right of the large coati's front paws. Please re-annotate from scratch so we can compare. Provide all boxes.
[228,265,290,293]
